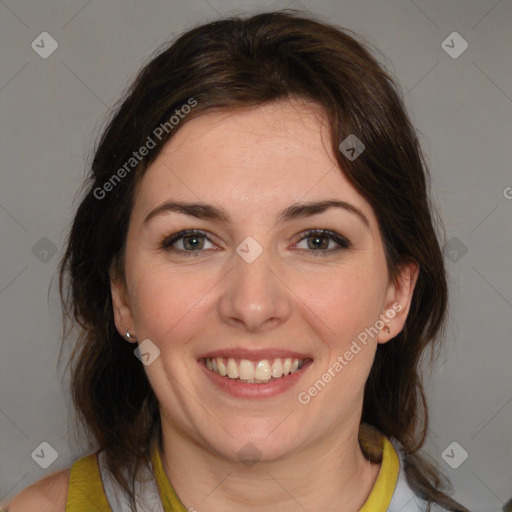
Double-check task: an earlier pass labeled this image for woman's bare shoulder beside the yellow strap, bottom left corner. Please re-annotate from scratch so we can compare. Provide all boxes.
[4,469,69,512]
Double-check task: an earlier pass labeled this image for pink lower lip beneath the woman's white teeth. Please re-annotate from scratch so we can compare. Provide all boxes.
[199,359,313,398]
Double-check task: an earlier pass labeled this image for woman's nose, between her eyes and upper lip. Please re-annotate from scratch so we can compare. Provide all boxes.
[218,243,293,332]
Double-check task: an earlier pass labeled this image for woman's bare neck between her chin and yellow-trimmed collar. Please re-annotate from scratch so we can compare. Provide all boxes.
[162,422,380,512]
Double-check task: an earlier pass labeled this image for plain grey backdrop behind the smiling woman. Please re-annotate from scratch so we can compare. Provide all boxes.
[0,0,512,512]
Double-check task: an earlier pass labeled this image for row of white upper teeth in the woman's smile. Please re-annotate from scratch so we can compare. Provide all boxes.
[205,357,304,382]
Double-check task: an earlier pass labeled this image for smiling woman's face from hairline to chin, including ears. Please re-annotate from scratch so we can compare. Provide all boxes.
[112,101,415,461]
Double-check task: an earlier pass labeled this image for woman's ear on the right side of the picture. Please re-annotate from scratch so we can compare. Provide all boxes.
[377,262,420,343]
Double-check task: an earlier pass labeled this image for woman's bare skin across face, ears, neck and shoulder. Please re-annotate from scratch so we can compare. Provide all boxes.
[6,101,418,512]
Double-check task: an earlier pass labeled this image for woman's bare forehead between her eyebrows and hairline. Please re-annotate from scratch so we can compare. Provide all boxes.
[132,101,371,221]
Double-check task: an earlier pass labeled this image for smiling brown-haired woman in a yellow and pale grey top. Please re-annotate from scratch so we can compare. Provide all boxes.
[4,11,474,512]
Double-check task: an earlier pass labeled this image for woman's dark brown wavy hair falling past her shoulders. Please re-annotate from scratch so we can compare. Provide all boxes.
[59,9,468,512]
